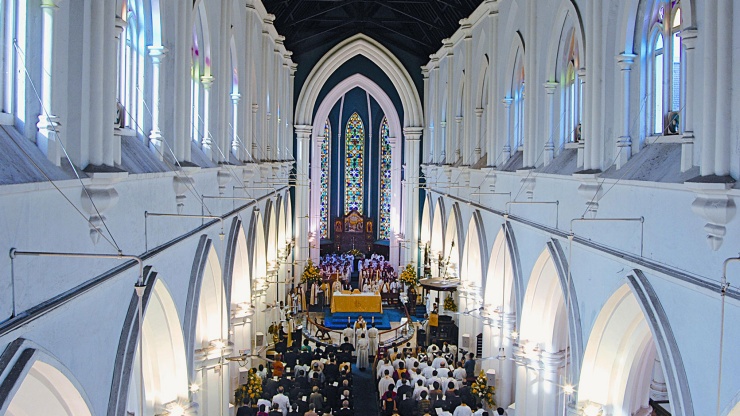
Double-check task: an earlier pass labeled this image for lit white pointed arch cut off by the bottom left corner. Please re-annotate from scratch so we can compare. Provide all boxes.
[0,339,92,416]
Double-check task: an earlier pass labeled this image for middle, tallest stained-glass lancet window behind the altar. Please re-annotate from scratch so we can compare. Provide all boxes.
[344,113,365,214]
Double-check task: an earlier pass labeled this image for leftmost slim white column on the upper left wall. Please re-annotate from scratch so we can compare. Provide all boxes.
[36,0,61,166]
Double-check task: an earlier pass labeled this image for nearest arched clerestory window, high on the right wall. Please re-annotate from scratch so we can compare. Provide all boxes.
[648,0,684,135]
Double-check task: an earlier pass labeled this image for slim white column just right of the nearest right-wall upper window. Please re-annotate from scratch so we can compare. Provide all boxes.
[681,29,698,172]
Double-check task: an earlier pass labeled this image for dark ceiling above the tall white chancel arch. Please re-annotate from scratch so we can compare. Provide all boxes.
[263,0,481,61]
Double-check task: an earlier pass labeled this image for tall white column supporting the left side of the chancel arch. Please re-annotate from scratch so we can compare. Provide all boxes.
[293,126,312,276]
